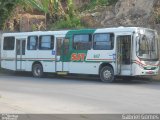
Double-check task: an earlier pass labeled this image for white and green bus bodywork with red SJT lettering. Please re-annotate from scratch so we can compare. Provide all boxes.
[1,27,159,79]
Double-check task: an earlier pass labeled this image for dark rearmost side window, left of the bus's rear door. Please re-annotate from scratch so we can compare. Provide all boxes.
[3,37,15,50]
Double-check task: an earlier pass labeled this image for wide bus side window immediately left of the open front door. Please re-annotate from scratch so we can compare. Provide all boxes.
[93,33,114,50]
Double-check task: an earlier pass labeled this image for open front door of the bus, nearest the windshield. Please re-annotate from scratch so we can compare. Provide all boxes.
[116,35,132,76]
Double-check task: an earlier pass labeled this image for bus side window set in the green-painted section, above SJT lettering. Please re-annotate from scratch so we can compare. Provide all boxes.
[73,34,92,50]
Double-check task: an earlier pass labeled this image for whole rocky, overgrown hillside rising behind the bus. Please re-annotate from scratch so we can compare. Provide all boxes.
[0,0,160,31]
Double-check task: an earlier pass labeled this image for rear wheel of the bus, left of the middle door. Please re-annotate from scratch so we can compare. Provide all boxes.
[32,64,44,78]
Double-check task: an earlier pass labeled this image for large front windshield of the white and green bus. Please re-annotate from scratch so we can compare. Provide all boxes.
[137,30,159,60]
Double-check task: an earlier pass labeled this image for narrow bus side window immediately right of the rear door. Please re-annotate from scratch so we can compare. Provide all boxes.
[27,36,38,50]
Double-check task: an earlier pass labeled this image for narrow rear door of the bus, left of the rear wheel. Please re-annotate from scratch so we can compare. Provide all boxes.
[16,39,26,71]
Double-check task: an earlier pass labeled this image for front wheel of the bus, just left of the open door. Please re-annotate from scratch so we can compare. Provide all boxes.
[100,66,114,83]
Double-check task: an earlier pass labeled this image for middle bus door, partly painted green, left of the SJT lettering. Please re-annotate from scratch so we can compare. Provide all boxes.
[55,38,69,72]
